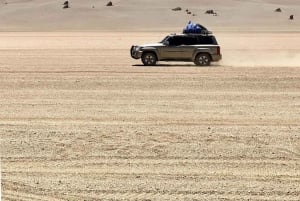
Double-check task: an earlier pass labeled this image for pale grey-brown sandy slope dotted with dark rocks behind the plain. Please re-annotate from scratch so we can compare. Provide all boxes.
[0,0,300,32]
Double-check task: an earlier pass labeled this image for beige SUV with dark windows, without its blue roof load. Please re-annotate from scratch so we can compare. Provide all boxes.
[130,34,222,66]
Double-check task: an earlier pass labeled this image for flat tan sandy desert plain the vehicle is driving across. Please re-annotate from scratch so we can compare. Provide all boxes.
[0,32,300,201]
